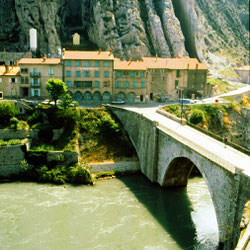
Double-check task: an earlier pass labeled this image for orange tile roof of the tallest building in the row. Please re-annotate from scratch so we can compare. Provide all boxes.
[63,50,114,60]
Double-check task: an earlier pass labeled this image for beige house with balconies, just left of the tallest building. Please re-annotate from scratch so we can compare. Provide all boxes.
[18,57,63,98]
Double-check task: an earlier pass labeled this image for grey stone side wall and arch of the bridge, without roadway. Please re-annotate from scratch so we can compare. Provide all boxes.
[108,106,250,249]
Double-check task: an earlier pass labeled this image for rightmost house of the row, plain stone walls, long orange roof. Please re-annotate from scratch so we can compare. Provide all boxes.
[142,57,211,100]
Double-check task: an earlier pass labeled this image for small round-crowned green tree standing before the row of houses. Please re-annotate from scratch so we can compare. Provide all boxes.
[46,78,67,106]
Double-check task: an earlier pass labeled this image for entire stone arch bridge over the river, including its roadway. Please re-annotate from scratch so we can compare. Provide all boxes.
[107,105,250,249]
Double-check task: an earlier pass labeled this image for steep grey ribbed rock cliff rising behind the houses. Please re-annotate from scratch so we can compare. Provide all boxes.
[0,0,249,62]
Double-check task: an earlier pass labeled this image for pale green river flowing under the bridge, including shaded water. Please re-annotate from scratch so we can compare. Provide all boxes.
[0,175,218,250]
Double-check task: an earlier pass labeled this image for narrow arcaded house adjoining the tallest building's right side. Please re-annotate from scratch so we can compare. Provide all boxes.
[113,59,147,102]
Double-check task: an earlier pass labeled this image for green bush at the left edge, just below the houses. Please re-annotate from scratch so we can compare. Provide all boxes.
[0,101,18,126]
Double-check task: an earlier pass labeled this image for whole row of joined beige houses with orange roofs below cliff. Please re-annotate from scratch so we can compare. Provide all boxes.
[0,50,211,102]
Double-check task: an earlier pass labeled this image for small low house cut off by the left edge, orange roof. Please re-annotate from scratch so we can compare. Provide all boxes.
[0,66,20,98]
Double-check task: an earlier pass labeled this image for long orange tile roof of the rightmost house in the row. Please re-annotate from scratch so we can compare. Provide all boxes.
[142,57,208,69]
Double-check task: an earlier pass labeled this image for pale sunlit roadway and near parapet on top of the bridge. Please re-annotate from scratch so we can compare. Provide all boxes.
[124,107,250,177]
